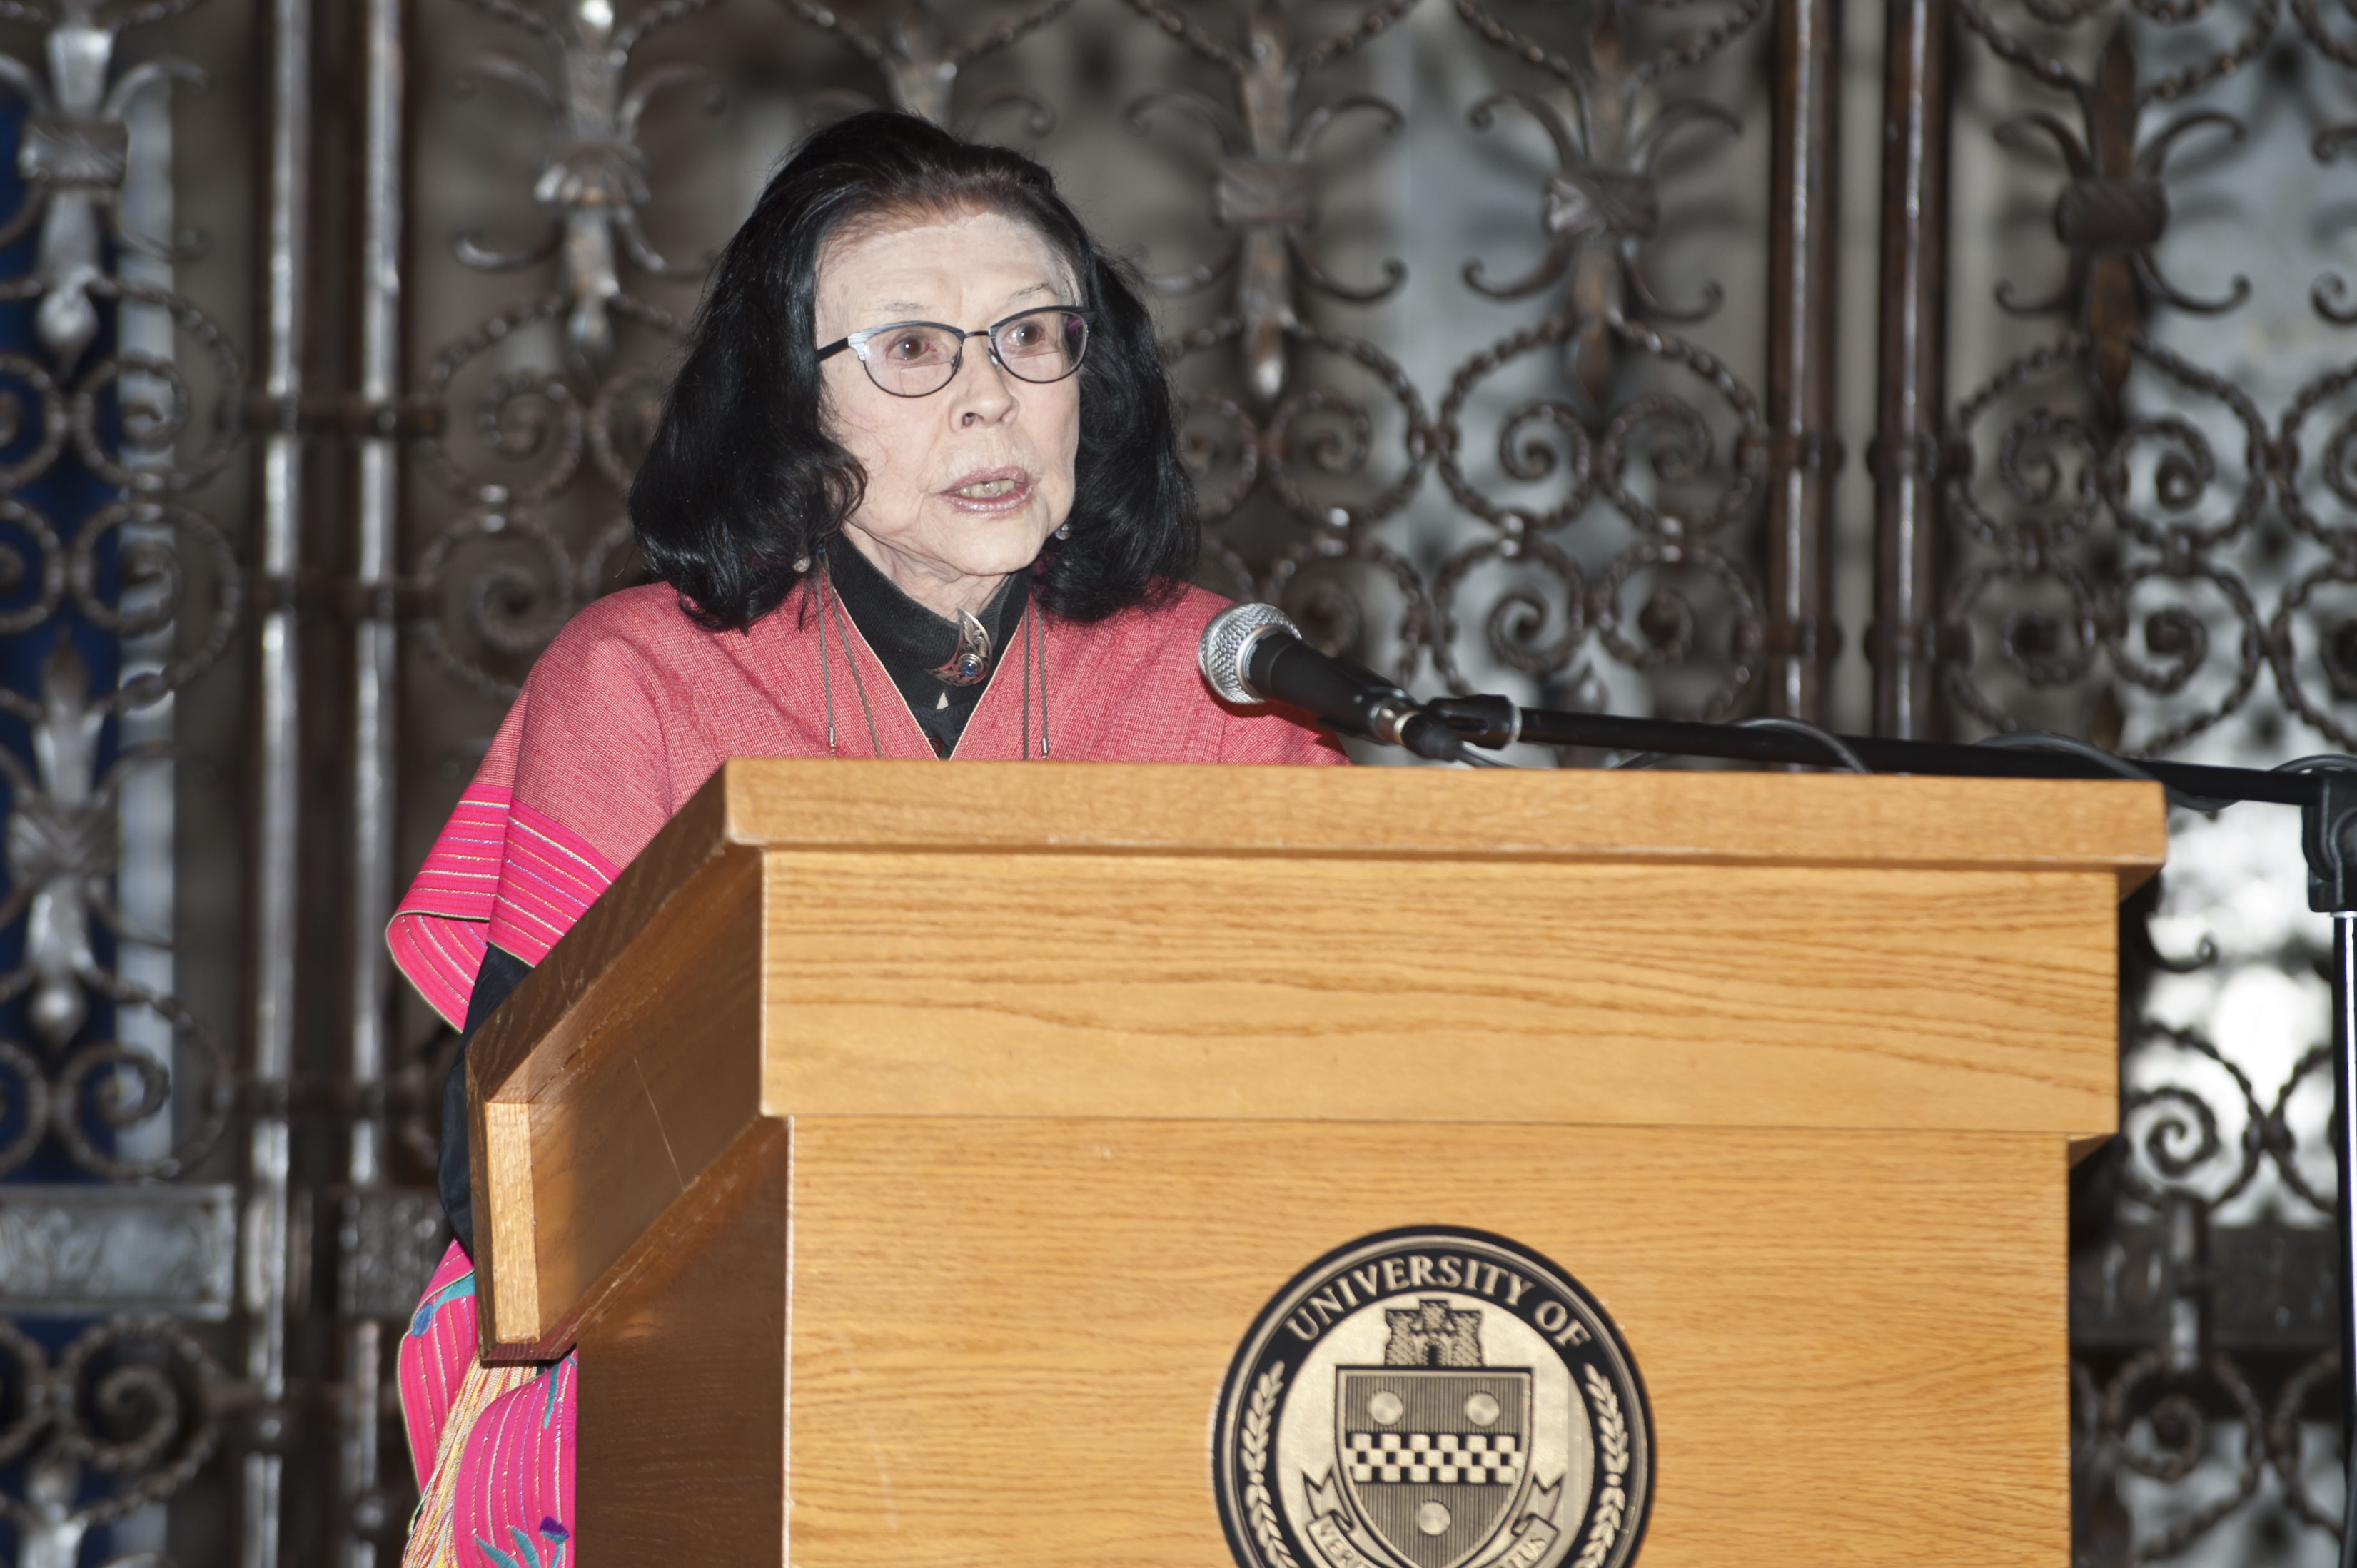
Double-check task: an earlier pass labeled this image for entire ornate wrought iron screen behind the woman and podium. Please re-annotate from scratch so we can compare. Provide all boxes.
[0,0,2357,1568]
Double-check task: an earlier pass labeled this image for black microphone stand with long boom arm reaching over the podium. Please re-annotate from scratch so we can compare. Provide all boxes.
[1423,696,2357,1568]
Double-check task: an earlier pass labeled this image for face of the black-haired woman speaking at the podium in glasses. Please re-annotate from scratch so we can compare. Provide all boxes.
[815,212,1079,615]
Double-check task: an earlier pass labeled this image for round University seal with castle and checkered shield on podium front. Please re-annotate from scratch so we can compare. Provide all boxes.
[1211,1226,1652,1568]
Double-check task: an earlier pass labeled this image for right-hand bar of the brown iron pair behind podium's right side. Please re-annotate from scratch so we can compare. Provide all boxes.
[1867,0,1952,740]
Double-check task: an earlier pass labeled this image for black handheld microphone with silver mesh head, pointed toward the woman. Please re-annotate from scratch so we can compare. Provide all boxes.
[1195,604,1466,762]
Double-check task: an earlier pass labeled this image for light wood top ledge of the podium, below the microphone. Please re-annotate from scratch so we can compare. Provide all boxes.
[657,759,2169,872]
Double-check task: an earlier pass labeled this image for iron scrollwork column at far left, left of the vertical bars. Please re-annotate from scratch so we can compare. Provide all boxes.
[0,0,256,1561]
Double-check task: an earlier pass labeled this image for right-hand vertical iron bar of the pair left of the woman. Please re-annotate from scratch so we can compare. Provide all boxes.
[344,0,405,1568]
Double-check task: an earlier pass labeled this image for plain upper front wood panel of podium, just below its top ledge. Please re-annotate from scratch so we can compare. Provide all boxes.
[764,851,2119,1136]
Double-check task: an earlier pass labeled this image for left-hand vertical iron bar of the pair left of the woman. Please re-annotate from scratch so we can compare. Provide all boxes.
[243,0,311,1568]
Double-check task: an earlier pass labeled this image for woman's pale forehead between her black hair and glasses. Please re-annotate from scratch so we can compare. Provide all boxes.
[818,212,1070,325]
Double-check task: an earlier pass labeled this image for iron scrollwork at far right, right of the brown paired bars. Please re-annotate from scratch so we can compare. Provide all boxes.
[1937,0,2357,1568]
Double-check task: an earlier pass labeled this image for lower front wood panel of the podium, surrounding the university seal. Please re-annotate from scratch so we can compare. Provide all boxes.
[787,1118,2069,1568]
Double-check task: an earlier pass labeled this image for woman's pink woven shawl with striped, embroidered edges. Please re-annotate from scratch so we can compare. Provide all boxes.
[387,585,1343,1568]
